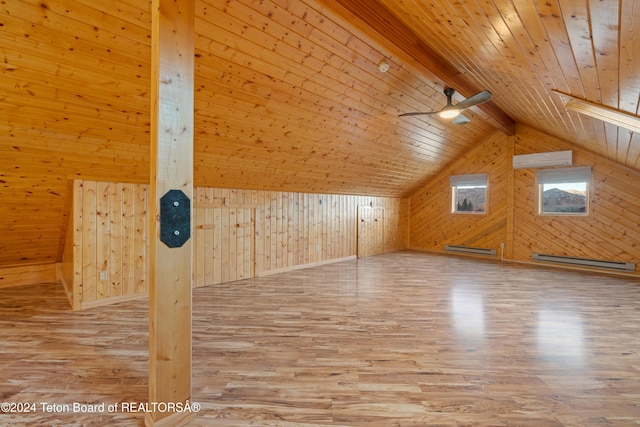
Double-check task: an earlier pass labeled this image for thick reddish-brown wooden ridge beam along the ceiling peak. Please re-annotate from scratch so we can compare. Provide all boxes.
[318,0,515,135]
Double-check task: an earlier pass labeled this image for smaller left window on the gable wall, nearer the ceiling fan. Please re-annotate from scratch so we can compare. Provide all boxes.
[449,173,487,214]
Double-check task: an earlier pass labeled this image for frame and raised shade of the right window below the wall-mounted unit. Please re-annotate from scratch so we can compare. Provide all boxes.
[536,166,593,218]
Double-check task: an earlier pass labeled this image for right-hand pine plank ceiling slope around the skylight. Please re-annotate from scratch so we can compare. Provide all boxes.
[370,0,640,169]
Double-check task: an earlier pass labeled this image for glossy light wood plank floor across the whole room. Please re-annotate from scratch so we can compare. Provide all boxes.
[0,252,640,427]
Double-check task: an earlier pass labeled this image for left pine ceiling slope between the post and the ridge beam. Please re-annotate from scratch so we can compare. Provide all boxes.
[195,1,510,196]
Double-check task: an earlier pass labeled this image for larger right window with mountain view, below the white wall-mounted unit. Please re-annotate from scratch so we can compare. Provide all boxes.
[536,166,591,216]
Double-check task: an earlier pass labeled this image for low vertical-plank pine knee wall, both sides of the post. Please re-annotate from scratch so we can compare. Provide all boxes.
[62,181,409,310]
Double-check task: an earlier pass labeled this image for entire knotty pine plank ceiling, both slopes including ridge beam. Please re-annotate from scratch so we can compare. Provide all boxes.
[0,0,640,266]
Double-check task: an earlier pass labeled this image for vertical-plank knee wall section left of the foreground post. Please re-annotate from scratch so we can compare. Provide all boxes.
[62,180,148,310]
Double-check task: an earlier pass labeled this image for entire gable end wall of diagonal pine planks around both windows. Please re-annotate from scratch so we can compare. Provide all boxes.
[409,125,640,275]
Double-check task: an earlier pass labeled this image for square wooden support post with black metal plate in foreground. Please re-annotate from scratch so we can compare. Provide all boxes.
[145,0,195,426]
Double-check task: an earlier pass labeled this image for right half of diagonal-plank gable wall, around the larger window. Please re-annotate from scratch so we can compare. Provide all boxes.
[511,127,640,275]
